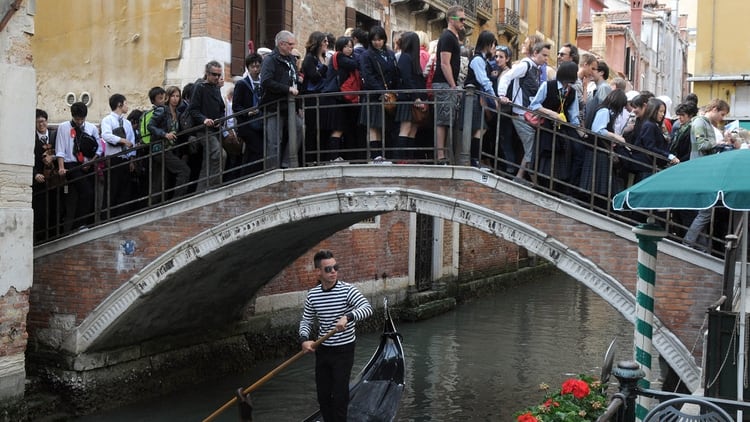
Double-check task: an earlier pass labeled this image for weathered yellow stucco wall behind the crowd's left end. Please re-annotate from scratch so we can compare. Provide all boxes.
[32,0,187,122]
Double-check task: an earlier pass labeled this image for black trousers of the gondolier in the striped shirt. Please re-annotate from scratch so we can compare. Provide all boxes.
[315,342,355,422]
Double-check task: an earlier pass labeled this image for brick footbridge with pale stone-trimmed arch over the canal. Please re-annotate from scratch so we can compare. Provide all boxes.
[29,166,722,390]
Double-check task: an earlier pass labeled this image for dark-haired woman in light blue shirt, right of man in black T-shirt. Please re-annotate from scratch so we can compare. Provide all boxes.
[464,31,497,167]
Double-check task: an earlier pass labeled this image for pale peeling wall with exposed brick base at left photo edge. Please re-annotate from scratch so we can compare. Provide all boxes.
[0,2,36,402]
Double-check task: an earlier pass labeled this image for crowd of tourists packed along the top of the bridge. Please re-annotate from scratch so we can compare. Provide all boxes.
[33,6,740,251]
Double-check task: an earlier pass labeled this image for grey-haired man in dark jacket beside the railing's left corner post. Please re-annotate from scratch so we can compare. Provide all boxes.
[260,31,303,168]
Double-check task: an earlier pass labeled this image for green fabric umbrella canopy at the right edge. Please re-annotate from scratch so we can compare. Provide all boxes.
[612,149,750,211]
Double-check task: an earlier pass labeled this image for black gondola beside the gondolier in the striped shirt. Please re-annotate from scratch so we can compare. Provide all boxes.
[304,300,404,422]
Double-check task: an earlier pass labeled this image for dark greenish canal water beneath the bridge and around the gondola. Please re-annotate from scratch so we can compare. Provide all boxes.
[77,273,633,422]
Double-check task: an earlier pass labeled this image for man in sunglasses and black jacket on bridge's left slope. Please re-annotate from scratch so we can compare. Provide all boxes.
[187,60,226,192]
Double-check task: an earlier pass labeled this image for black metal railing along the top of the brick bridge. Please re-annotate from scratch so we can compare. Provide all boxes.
[34,89,733,262]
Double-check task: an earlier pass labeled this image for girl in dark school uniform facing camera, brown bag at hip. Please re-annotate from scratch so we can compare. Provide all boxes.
[359,26,399,162]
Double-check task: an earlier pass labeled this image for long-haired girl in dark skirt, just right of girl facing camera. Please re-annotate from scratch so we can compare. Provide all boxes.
[393,31,429,160]
